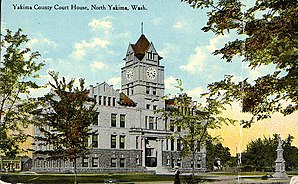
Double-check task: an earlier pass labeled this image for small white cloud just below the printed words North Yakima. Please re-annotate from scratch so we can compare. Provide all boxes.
[88,16,113,34]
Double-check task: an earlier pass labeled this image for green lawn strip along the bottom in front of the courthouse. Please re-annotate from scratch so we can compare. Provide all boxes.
[0,171,298,184]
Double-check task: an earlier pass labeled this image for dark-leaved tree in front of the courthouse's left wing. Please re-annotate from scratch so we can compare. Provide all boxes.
[33,72,97,183]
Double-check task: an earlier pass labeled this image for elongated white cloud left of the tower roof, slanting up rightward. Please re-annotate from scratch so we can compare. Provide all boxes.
[72,37,110,60]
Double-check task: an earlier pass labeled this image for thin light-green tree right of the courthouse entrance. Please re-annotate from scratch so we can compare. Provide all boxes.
[157,79,235,176]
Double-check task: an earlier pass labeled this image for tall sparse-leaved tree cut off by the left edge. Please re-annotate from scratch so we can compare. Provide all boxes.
[0,29,44,157]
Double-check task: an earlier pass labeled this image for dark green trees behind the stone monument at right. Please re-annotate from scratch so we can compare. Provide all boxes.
[242,134,298,171]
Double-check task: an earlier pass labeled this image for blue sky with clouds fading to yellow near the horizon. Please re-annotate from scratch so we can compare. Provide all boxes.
[1,0,298,154]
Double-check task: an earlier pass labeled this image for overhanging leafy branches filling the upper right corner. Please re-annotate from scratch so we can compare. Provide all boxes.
[181,0,298,127]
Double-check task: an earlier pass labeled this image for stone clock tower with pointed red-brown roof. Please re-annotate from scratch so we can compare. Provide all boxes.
[121,34,164,110]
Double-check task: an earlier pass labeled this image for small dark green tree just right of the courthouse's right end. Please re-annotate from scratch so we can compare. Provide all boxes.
[206,139,231,170]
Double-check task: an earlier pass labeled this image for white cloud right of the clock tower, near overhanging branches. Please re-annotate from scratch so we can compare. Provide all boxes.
[180,47,207,73]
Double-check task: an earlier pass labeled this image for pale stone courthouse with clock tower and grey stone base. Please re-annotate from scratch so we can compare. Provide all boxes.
[32,34,206,172]
